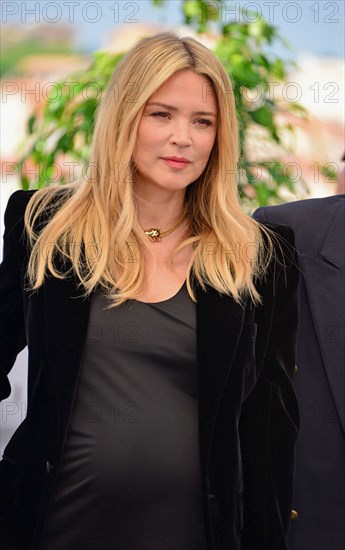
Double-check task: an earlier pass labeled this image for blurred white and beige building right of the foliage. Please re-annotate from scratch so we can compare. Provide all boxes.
[238,55,345,200]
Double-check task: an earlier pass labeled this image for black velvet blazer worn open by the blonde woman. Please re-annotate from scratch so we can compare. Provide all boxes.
[0,190,299,550]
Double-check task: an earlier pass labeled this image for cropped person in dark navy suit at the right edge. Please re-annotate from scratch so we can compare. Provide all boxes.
[254,195,345,550]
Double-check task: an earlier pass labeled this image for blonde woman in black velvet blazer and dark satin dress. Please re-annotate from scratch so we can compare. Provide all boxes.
[0,33,298,550]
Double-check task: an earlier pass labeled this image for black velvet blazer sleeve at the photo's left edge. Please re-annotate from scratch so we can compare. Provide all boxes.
[0,191,26,401]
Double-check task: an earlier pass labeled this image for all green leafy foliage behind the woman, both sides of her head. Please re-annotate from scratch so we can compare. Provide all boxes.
[20,0,306,206]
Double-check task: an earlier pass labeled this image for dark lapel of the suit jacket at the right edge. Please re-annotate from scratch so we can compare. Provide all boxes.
[300,205,345,431]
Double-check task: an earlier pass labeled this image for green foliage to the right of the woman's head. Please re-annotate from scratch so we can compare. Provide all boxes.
[215,9,306,206]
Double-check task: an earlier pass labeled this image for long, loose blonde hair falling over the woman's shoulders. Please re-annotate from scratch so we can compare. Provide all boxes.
[24,32,271,307]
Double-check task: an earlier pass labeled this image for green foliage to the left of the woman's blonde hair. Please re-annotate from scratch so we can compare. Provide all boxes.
[18,51,123,189]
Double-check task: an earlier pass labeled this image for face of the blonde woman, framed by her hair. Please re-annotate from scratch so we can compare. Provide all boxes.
[133,70,218,196]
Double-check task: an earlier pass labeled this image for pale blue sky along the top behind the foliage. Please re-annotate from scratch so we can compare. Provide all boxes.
[1,0,345,58]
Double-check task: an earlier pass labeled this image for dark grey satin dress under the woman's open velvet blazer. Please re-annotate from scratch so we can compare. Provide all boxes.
[40,283,206,550]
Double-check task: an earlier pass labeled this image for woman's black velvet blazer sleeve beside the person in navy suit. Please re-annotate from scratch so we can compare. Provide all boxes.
[240,226,299,550]
